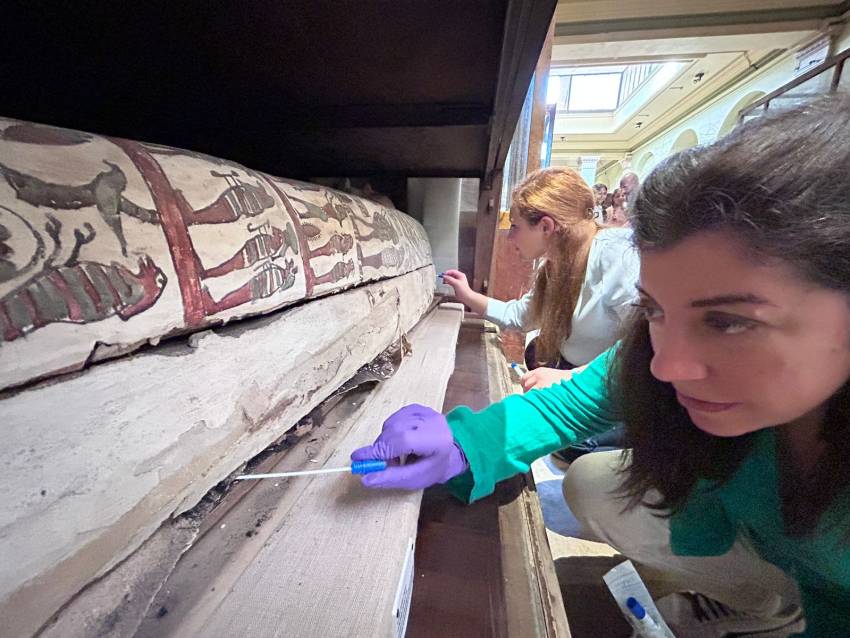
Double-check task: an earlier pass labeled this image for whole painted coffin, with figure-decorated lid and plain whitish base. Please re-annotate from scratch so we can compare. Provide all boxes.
[0,119,434,636]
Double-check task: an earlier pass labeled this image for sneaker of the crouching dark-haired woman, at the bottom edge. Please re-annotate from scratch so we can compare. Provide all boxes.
[656,592,806,638]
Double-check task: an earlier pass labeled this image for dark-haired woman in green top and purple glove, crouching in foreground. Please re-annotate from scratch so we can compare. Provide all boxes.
[352,96,850,637]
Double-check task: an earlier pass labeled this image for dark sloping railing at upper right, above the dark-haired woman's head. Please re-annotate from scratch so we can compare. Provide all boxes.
[738,49,850,123]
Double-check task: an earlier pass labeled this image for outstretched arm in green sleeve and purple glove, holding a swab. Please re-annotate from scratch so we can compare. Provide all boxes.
[352,350,619,501]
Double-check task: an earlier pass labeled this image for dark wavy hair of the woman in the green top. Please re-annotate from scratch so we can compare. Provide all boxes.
[610,95,850,535]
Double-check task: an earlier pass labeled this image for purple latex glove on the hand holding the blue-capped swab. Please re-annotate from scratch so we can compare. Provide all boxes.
[351,403,469,490]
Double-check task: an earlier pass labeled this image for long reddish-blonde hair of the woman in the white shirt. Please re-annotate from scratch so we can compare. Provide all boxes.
[511,168,598,366]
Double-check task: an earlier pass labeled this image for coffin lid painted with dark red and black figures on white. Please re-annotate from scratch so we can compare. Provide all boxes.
[0,119,431,388]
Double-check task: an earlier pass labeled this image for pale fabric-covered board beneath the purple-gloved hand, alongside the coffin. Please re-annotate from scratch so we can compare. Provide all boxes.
[168,304,463,637]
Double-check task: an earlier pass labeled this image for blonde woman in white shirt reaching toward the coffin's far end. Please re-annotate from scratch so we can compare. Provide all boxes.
[443,168,639,390]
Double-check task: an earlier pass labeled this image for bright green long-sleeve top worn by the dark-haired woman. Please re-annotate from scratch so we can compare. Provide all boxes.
[446,350,850,638]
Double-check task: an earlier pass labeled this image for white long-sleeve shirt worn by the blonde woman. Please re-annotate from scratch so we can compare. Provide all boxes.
[485,228,640,366]
